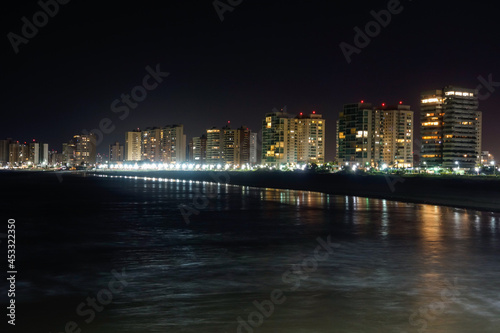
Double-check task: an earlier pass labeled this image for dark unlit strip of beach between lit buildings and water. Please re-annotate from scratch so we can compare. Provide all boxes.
[92,170,500,212]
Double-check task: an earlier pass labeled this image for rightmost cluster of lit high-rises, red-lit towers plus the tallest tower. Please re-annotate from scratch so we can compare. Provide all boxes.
[336,86,488,170]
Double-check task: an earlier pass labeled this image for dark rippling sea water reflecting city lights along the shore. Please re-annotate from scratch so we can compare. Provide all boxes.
[0,173,500,333]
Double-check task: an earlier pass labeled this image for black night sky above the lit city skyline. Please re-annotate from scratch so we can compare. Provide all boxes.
[0,0,500,160]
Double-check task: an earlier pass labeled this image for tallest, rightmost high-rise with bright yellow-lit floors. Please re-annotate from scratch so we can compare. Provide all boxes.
[421,86,482,169]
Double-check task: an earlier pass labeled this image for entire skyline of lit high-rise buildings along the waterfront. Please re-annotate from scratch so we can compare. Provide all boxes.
[0,86,495,170]
